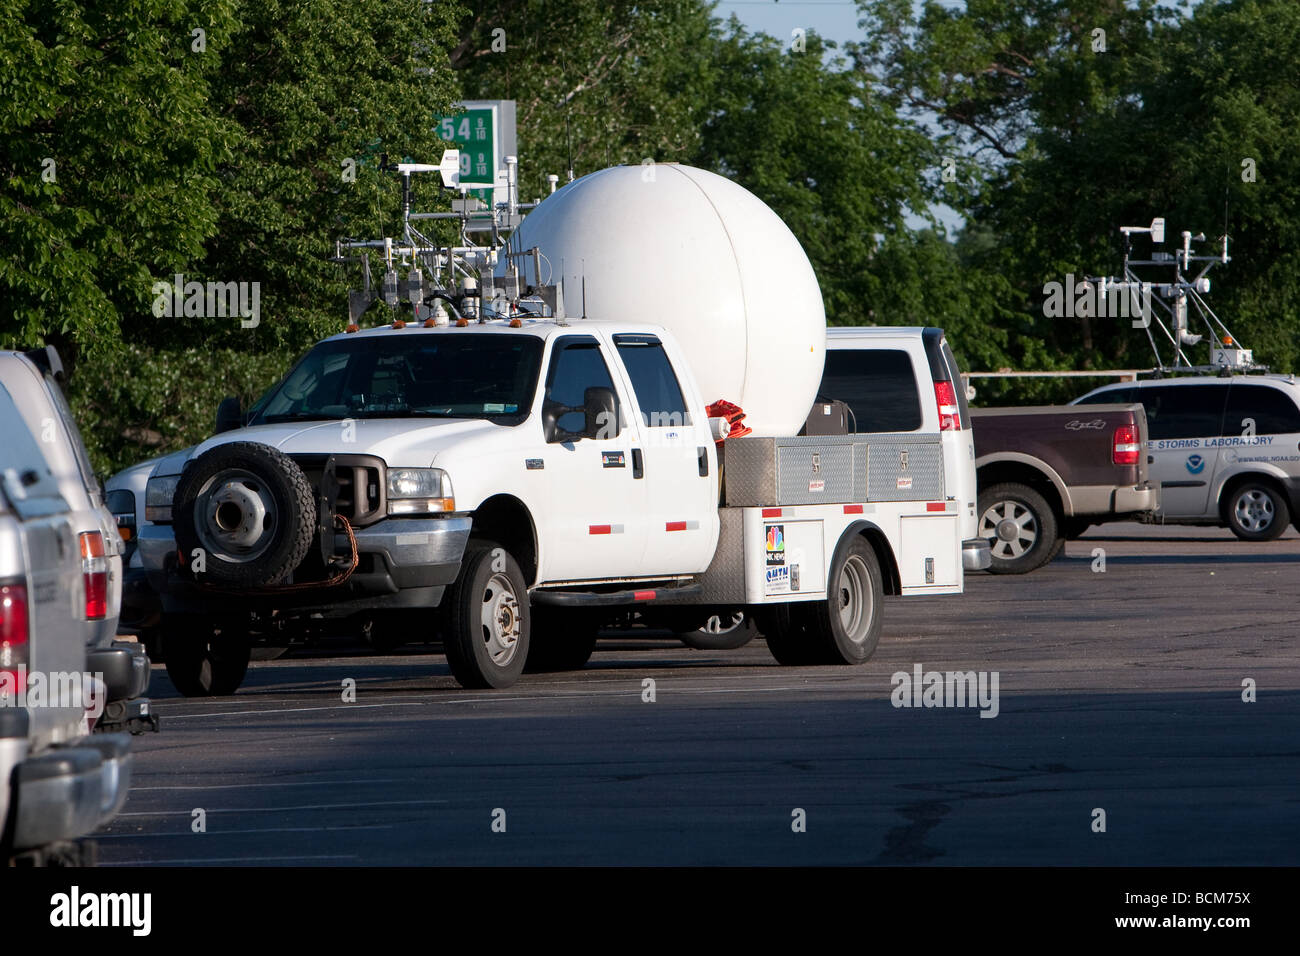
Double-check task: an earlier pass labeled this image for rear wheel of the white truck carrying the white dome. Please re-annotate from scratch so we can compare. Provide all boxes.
[807,535,885,663]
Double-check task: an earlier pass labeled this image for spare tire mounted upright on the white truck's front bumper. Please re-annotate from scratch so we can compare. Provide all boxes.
[172,441,316,588]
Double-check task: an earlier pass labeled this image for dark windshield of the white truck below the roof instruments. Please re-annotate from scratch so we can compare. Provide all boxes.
[248,333,542,425]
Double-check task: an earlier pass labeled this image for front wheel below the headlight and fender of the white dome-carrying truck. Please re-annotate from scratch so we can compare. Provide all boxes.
[442,538,530,688]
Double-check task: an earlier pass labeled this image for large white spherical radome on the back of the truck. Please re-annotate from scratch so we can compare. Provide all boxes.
[511,164,826,436]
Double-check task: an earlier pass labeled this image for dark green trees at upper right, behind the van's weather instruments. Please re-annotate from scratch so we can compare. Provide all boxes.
[858,0,1300,398]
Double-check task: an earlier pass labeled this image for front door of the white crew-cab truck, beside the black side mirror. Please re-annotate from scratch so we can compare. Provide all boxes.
[540,334,647,581]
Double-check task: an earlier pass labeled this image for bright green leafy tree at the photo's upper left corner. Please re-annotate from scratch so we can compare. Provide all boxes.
[0,0,237,362]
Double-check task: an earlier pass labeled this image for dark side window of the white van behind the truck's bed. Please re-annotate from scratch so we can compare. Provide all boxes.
[818,349,925,432]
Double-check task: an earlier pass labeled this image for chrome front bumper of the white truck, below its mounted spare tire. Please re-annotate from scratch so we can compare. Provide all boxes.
[139,515,472,611]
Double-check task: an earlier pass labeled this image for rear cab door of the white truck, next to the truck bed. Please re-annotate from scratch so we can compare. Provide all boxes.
[614,333,718,575]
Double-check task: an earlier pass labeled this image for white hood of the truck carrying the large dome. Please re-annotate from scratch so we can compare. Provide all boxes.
[166,419,504,475]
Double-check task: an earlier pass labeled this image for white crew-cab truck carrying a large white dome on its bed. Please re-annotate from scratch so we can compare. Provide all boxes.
[139,160,987,695]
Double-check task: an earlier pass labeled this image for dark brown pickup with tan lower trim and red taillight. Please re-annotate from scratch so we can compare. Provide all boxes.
[971,405,1158,574]
